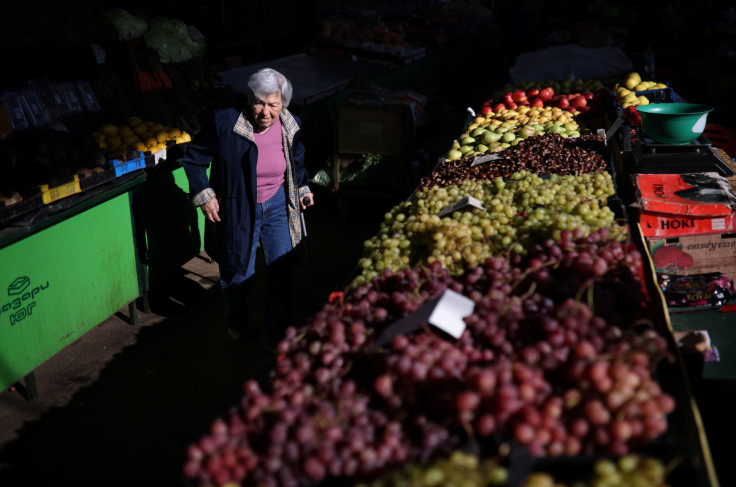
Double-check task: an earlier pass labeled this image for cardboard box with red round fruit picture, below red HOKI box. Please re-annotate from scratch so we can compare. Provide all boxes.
[645,233,736,279]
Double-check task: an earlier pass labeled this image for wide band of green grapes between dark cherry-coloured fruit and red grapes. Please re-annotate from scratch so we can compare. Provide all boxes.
[354,171,627,285]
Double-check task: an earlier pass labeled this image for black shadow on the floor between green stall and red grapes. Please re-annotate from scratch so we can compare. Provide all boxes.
[0,272,272,487]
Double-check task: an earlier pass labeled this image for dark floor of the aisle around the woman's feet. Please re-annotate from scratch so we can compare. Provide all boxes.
[0,190,388,487]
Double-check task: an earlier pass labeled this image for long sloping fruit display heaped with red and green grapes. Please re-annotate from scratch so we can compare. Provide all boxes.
[183,73,718,487]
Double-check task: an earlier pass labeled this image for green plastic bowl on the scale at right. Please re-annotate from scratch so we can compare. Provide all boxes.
[636,103,713,144]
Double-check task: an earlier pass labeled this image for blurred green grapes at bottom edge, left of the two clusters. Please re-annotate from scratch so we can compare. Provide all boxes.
[355,450,508,487]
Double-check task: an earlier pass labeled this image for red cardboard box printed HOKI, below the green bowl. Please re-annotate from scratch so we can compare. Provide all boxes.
[633,173,736,237]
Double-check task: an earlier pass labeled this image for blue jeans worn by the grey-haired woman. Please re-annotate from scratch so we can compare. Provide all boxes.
[220,185,293,346]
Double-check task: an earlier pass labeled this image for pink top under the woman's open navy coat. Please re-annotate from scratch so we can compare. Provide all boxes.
[253,117,286,203]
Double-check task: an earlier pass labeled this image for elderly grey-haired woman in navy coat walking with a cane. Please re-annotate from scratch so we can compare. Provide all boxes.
[182,68,314,347]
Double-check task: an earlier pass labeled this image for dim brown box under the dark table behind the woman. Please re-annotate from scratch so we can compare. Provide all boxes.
[337,101,414,156]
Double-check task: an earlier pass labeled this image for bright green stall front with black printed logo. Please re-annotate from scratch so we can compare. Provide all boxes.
[0,173,145,397]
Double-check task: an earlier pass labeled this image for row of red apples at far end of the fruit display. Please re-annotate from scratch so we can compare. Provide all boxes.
[481,86,596,115]
